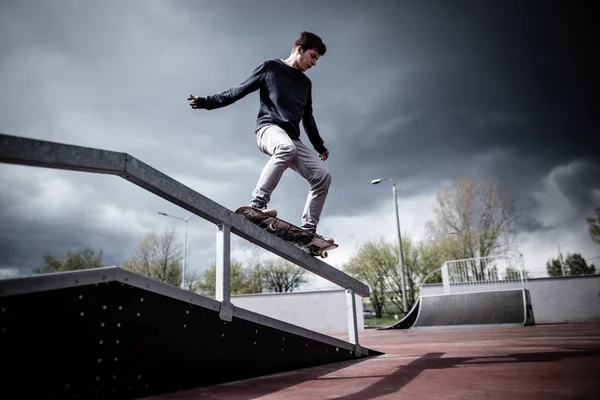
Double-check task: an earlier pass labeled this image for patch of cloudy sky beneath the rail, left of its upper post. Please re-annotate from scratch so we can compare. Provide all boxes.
[0,166,226,273]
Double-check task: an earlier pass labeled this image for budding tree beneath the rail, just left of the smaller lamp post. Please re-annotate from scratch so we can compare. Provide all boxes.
[123,229,183,286]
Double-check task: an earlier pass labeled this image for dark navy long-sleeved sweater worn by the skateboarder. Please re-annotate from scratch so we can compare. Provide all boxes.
[199,59,327,154]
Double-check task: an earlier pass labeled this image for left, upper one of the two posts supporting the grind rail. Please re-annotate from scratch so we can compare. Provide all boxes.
[215,224,233,321]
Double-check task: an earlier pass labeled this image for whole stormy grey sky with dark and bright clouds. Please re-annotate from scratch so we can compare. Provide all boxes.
[0,0,600,287]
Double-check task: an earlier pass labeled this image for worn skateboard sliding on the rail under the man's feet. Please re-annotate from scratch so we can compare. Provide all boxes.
[235,206,339,258]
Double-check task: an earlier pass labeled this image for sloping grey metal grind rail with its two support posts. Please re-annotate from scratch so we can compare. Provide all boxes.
[0,134,370,353]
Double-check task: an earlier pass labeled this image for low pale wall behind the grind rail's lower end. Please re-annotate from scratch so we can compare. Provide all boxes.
[231,289,364,333]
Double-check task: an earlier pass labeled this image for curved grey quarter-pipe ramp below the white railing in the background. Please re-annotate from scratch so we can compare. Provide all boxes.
[384,289,535,329]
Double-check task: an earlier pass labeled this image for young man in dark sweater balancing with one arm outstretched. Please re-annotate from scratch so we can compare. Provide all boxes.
[188,32,331,239]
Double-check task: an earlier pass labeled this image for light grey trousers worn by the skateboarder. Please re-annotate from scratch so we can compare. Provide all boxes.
[252,125,331,233]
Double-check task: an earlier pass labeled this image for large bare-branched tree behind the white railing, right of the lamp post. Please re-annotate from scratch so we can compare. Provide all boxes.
[427,178,517,272]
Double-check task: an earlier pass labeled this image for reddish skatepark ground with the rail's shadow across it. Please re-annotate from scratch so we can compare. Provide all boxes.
[148,322,600,400]
